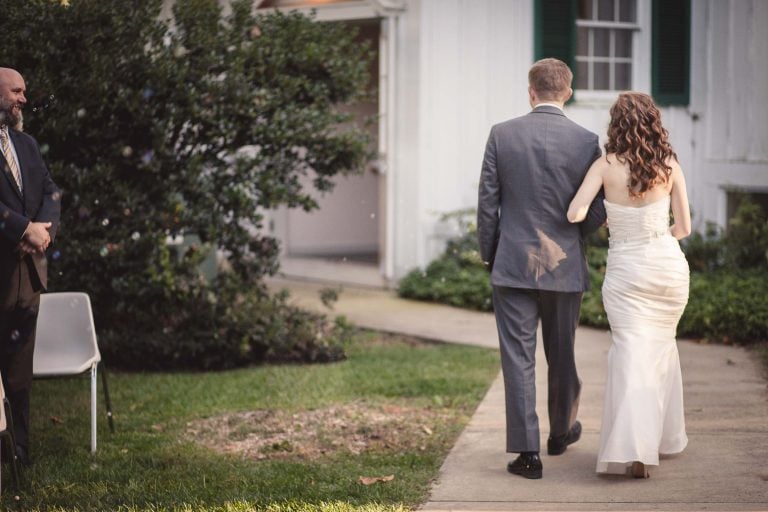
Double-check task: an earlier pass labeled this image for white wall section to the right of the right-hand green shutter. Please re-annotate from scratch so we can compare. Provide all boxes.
[690,0,768,228]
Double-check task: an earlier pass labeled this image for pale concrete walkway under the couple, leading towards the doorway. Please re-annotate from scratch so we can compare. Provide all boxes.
[271,280,768,511]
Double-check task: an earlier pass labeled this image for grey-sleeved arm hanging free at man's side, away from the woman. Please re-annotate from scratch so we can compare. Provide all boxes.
[477,129,501,270]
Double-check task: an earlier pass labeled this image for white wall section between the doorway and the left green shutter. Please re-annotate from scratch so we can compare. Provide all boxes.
[395,0,533,277]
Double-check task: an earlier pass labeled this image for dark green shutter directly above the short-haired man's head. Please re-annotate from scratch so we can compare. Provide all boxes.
[533,0,577,103]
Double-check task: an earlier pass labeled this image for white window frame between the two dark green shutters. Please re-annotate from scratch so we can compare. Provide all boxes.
[574,0,652,105]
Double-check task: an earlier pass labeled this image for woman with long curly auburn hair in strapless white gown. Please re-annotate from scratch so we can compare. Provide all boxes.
[568,92,691,478]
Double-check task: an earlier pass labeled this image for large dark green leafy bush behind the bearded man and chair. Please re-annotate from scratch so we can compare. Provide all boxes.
[0,0,369,368]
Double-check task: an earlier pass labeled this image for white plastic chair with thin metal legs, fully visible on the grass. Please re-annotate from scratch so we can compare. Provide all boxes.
[33,292,115,453]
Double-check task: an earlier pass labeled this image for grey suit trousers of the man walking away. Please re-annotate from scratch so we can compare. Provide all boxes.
[493,286,582,453]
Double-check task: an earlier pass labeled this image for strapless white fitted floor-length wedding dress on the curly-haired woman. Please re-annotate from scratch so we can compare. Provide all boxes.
[597,196,689,474]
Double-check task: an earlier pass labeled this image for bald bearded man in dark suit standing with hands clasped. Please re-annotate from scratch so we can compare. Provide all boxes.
[0,68,61,465]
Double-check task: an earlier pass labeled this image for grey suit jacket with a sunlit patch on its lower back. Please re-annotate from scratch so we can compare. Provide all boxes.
[477,106,605,292]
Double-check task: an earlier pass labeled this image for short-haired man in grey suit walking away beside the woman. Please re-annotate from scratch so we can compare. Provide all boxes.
[477,59,605,478]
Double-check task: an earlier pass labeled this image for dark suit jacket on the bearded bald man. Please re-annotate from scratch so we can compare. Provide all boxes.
[0,129,61,290]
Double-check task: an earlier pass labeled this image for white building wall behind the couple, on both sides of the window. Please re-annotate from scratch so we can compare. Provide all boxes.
[252,0,768,279]
